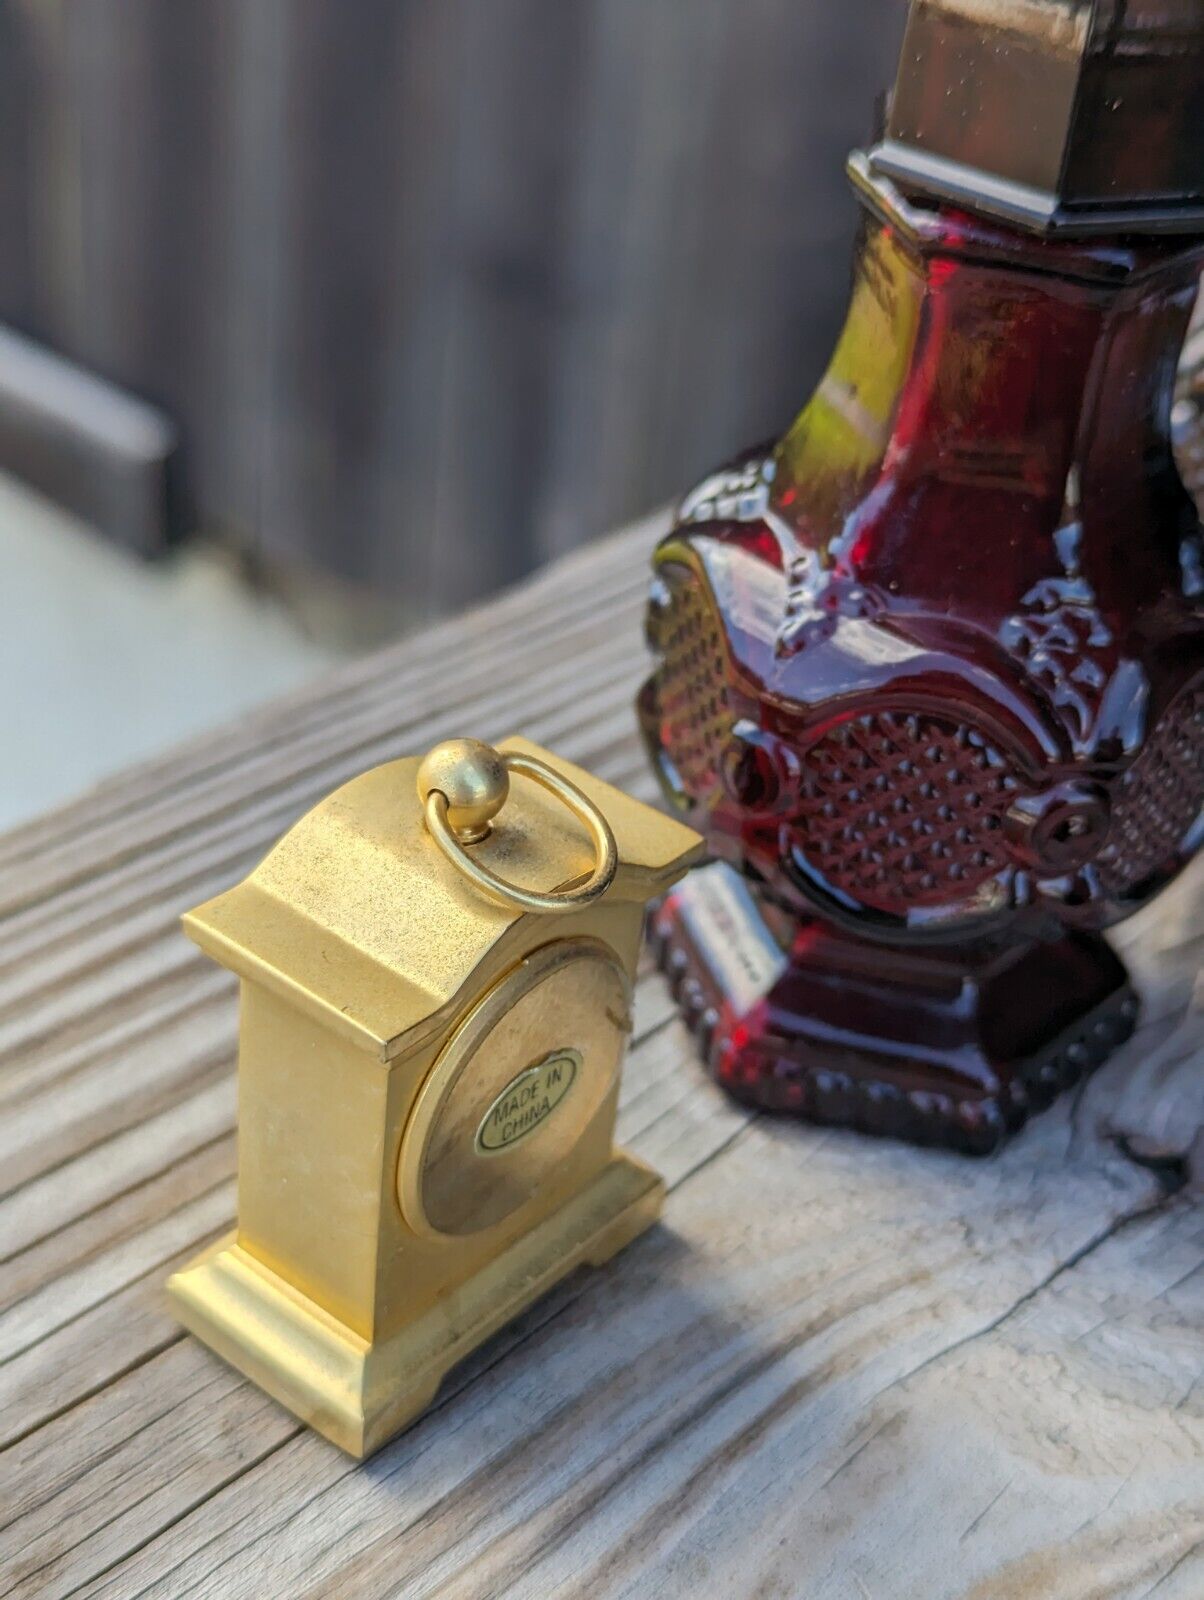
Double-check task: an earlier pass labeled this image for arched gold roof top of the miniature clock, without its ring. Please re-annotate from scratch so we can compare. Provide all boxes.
[184,738,701,1061]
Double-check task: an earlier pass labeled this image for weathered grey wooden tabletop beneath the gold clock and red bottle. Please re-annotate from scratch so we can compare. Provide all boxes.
[0,526,1204,1600]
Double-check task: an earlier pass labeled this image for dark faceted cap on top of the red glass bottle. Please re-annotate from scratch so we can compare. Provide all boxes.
[871,0,1204,234]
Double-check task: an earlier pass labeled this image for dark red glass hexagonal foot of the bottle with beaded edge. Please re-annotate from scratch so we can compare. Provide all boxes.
[652,864,1138,1155]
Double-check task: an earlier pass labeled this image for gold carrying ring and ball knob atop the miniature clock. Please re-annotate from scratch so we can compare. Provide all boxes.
[418,739,618,915]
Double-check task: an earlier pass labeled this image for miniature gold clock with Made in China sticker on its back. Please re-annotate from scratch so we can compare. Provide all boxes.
[168,739,701,1456]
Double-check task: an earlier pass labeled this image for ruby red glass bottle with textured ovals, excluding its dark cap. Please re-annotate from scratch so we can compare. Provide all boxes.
[639,144,1204,1152]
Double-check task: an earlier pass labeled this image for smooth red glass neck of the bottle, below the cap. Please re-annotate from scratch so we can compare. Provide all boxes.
[773,184,1201,606]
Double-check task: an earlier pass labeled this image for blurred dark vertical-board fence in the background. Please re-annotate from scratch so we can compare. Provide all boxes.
[0,0,903,606]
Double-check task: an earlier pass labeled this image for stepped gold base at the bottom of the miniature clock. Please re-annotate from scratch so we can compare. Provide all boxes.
[168,1152,664,1459]
